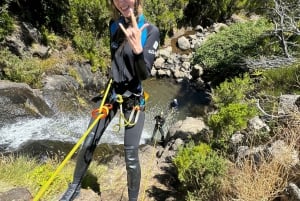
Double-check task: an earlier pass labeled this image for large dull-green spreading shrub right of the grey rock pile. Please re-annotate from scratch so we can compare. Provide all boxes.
[194,18,272,68]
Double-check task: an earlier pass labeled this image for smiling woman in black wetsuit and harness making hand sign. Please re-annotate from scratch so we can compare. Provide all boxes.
[60,0,160,201]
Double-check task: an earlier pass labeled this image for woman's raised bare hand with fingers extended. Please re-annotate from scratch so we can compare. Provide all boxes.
[119,8,148,54]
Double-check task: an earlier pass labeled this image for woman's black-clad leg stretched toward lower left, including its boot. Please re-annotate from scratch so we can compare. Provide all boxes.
[60,103,116,201]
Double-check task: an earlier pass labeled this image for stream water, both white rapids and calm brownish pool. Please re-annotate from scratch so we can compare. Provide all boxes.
[0,79,208,155]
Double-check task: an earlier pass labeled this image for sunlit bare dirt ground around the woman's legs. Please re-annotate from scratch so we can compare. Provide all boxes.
[75,145,184,201]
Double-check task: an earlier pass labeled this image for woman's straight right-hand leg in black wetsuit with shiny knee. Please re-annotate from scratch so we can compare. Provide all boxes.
[124,111,145,201]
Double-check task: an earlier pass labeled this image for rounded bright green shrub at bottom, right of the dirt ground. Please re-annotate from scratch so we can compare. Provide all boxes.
[173,142,226,201]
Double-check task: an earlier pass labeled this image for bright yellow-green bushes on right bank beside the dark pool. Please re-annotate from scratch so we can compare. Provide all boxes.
[208,74,258,151]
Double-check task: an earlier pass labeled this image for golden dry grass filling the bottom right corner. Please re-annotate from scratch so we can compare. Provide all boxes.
[230,115,300,201]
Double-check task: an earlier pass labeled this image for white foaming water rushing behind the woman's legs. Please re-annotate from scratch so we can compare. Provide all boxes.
[0,110,157,151]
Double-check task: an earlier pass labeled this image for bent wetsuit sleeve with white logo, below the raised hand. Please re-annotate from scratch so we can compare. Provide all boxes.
[134,24,160,80]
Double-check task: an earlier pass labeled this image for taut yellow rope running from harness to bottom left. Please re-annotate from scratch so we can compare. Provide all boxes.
[33,79,112,201]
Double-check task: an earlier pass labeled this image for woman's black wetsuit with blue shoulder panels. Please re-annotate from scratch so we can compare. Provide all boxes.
[60,15,159,201]
